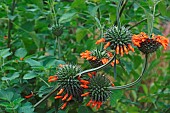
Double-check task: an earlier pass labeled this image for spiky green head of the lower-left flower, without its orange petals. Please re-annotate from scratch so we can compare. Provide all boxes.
[56,64,83,101]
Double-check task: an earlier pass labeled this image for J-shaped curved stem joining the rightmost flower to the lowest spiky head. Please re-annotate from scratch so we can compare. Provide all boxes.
[108,54,148,90]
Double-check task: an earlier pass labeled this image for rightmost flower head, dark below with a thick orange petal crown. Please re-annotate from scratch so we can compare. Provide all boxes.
[132,32,169,54]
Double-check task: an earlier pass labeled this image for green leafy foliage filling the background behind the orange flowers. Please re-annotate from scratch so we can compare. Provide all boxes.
[0,0,170,113]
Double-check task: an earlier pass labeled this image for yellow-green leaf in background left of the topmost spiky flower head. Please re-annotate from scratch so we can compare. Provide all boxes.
[76,28,87,42]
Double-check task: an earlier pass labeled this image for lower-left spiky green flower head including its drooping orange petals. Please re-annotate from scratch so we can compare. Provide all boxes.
[48,64,83,109]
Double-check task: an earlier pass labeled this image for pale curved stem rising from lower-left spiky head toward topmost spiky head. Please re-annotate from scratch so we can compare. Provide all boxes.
[75,55,115,77]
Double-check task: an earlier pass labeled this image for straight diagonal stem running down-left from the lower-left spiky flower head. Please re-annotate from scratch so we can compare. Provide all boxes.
[34,86,59,108]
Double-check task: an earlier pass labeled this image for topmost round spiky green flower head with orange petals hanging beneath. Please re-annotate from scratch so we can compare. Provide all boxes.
[96,26,134,56]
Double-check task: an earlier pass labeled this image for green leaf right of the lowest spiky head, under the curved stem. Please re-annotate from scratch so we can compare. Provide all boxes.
[110,90,123,106]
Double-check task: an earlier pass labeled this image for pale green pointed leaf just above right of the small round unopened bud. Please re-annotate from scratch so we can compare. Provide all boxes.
[59,12,76,23]
